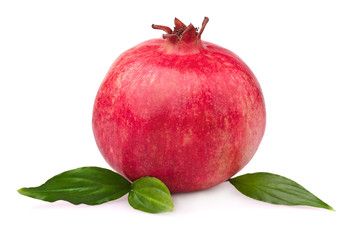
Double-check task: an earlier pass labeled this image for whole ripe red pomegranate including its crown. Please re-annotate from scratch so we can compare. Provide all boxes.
[92,18,266,193]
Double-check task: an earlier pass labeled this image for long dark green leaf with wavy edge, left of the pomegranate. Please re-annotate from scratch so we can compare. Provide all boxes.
[18,167,131,205]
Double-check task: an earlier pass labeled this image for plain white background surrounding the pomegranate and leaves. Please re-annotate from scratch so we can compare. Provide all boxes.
[0,0,350,239]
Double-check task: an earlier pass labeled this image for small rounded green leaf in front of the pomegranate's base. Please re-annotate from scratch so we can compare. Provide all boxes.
[128,177,174,213]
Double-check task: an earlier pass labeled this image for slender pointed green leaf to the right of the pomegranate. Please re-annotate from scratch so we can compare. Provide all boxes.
[229,172,334,211]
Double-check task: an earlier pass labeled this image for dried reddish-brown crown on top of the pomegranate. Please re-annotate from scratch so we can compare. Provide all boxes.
[152,17,209,43]
